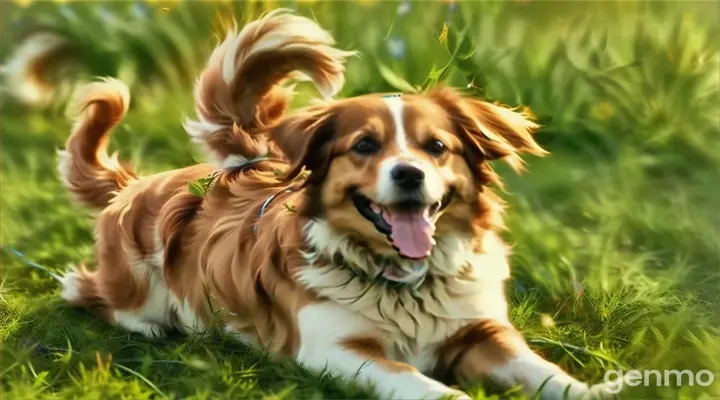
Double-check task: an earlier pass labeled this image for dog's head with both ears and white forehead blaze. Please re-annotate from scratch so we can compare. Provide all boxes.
[271,89,543,280]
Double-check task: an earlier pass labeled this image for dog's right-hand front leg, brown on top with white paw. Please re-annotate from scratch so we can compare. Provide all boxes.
[439,319,611,400]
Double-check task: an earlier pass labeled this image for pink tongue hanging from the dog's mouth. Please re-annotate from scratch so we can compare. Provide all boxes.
[385,209,435,258]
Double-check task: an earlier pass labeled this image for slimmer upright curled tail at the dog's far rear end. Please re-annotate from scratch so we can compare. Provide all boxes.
[58,78,137,209]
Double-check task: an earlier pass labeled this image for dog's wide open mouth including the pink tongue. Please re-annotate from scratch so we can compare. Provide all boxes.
[351,190,453,261]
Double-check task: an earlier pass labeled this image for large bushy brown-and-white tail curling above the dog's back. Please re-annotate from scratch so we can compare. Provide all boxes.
[185,9,355,167]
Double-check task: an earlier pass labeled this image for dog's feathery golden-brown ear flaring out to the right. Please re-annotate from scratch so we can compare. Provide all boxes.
[429,87,547,171]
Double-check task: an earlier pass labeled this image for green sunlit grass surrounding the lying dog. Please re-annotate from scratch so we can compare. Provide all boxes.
[0,1,720,399]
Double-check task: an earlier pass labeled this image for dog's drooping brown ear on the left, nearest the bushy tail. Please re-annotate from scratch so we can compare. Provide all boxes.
[270,105,335,183]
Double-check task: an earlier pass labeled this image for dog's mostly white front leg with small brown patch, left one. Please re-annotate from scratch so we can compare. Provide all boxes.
[297,302,469,400]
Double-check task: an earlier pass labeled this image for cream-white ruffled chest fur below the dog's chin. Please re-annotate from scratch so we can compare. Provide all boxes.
[296,222,509,371]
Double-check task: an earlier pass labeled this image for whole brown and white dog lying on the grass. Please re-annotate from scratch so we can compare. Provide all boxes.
[59,10,602,399]
